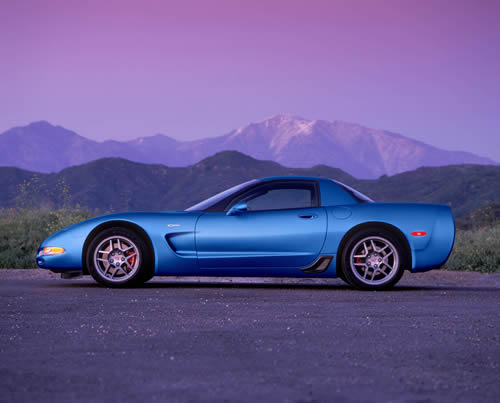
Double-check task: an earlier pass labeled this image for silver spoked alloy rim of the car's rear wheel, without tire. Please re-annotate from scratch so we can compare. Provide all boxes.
[350,236,400,285]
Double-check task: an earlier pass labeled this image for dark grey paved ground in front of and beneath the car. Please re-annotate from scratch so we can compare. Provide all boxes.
[0,270,500,402]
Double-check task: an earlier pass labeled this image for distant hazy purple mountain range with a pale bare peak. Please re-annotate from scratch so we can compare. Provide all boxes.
[0,115,496,179]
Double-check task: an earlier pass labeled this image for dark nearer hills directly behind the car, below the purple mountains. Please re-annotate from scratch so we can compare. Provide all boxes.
[0,151,500,217]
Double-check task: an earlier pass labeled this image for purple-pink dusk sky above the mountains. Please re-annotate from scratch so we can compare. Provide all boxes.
[0,0,500,161]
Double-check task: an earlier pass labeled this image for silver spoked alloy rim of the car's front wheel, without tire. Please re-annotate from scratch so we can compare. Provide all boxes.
[94,235,141,282]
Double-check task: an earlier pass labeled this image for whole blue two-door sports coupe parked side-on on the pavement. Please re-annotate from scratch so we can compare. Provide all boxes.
[36,177,455,290]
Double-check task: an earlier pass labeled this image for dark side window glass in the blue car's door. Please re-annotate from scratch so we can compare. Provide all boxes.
[233,183,317,211]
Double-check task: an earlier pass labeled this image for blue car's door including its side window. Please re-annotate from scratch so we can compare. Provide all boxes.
[196,180,327,270]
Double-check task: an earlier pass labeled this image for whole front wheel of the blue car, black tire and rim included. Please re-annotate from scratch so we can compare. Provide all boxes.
[86,227,154,288]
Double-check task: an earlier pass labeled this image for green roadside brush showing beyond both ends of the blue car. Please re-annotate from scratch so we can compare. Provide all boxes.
[0,208,500,273]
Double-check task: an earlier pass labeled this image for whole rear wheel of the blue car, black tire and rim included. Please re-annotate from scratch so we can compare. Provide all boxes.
[341,228,409,290]
